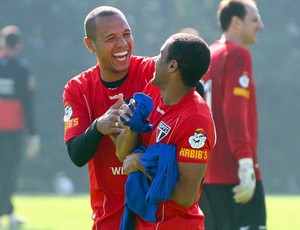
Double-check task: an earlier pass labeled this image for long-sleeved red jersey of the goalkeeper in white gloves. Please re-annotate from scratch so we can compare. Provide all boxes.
[202,41,261,184]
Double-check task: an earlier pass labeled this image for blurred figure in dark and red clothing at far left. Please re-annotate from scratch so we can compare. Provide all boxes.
[0,25,40,227]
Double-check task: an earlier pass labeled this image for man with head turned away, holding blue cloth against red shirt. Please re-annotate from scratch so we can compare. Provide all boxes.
[116,33,216,230]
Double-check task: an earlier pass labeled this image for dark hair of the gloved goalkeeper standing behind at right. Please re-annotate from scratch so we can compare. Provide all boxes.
[217,0,246,31]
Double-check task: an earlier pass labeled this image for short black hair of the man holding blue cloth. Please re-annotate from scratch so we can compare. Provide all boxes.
[167,33,210,87]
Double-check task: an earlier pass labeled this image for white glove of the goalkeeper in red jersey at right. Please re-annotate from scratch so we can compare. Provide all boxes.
[232,158,256,204]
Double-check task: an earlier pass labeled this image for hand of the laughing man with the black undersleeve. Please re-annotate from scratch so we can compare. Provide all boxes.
[97,94,124,135]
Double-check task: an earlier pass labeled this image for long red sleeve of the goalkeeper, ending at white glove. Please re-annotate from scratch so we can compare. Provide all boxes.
[222,48,254,159]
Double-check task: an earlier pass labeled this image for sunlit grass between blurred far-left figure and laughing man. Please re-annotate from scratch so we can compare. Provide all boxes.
[5,195,92,230]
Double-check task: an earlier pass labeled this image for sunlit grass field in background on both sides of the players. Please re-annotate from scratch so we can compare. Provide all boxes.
[0,195,300,230]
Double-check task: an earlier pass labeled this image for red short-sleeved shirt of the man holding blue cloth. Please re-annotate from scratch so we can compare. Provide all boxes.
[136,83,215,230]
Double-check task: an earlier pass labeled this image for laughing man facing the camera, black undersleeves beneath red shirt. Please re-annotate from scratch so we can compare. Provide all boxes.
[63,6,155,230]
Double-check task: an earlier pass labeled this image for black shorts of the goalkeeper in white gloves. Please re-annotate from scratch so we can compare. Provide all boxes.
[199,181,267,230]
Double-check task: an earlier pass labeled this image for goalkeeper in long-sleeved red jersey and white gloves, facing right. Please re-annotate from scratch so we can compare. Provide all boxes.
[200,0,266,230]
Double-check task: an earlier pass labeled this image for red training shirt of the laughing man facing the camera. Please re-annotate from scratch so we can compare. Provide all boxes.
[63,56,155,230]
